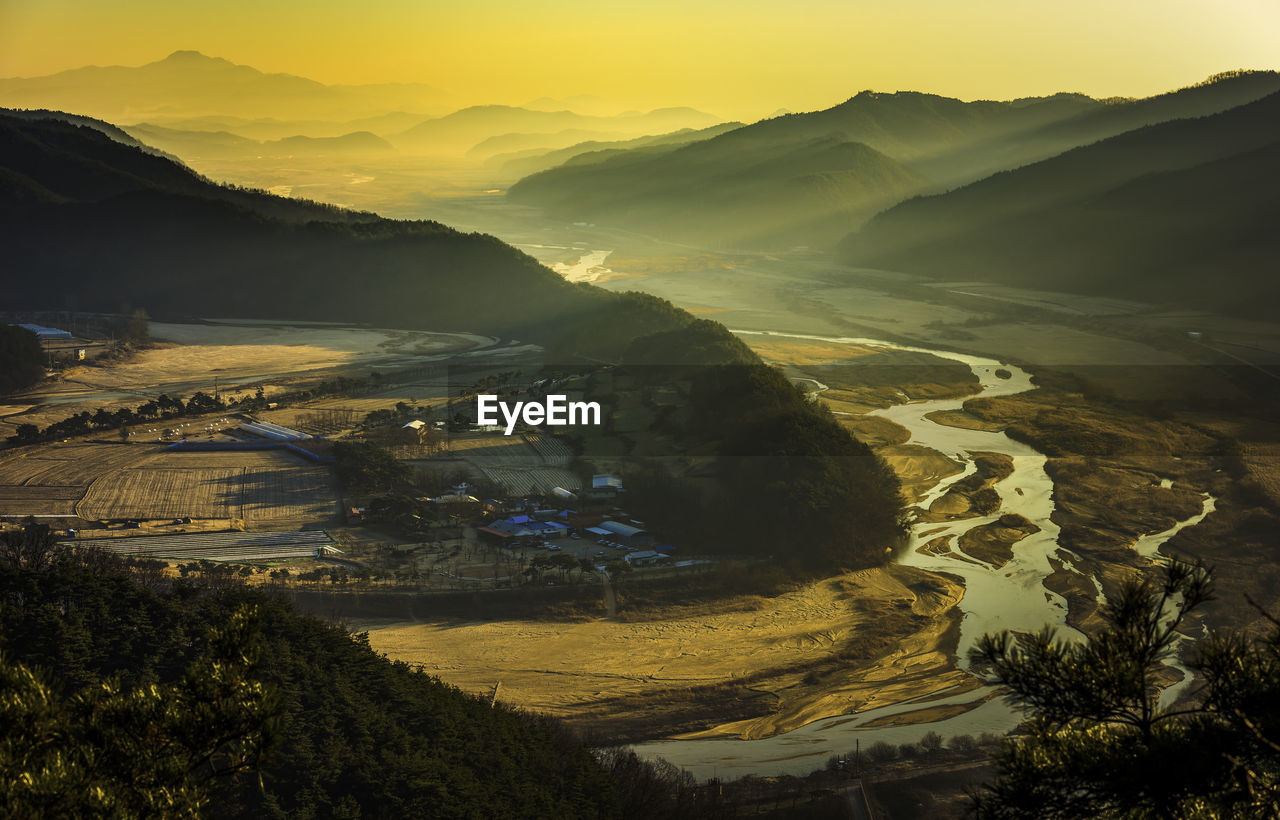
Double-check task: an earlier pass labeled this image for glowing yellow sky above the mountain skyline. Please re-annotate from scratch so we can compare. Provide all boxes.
[0,0,1280,116]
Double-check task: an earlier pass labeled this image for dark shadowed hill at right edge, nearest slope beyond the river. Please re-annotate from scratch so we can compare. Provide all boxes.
[842,93,1280,315]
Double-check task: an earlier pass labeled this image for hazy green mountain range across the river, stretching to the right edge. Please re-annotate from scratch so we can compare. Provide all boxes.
[508,72,1280,248]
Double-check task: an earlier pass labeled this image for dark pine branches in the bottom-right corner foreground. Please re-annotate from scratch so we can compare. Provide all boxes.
[973,562,1280,817]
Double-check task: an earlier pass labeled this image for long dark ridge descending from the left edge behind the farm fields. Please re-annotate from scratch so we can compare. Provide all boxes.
[0,108,678,358]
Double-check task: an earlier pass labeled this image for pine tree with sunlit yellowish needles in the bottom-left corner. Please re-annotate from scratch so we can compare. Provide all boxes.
[0,606,278,817]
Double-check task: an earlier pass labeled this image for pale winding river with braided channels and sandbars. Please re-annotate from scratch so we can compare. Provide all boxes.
[636,331,1213,778]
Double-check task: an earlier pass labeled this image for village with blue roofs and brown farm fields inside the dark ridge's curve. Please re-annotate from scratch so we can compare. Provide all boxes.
[0,317,710,591]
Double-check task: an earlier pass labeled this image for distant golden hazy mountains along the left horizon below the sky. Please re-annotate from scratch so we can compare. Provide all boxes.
[0,51,719,157]
